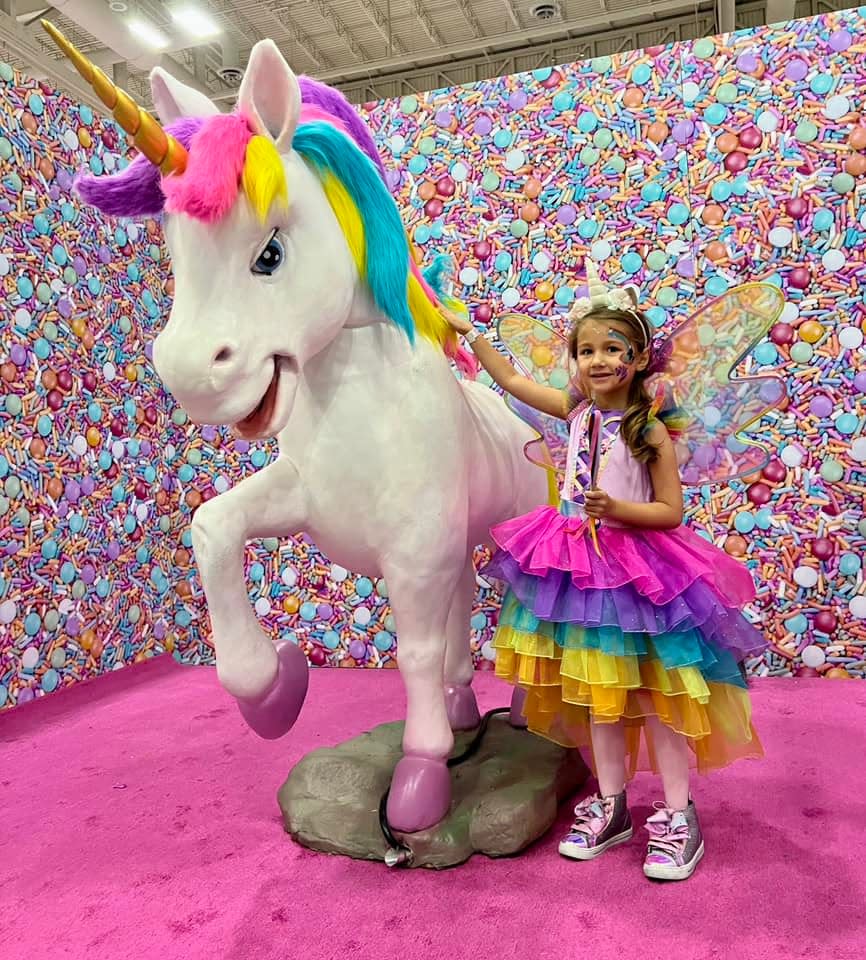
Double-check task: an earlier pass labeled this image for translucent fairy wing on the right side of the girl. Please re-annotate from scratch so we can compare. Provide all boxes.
[653,283,785,487]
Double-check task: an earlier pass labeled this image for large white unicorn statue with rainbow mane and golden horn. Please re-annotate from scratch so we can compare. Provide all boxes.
[43,28,547,833]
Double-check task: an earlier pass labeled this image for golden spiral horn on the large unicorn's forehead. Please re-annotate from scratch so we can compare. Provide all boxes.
[40,20,187,176]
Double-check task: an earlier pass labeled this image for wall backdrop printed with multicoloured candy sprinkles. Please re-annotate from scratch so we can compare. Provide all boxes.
[0,9,866,707]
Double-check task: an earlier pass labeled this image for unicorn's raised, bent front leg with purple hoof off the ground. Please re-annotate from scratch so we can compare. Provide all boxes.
[192,459,308,739]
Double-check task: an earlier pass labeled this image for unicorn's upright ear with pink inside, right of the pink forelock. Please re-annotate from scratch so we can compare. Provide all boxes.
[238,40,301,153]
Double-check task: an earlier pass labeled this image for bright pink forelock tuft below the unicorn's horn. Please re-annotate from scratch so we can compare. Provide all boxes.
[162,114,252,223]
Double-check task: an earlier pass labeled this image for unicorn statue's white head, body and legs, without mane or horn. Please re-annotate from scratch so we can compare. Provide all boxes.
[64,33,547,831]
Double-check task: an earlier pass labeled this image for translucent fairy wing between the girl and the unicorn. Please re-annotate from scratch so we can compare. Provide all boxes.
[497,313,577,476]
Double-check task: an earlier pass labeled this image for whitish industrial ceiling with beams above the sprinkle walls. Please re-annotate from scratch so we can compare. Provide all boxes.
[0,0,857,105]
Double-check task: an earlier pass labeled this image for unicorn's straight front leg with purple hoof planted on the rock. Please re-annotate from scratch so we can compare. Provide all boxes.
[386,561,459,833]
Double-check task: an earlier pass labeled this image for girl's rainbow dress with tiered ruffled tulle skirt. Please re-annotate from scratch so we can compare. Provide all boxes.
[484,407,767,773]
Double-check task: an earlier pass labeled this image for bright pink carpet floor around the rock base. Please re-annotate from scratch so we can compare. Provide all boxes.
[0,659,866,960]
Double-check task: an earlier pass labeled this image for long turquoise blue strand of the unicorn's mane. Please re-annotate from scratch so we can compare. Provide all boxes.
[292,120,415,343]
